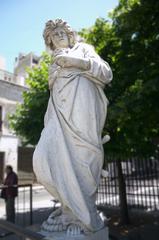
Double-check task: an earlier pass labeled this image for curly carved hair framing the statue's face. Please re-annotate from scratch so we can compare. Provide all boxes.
[43,19,76,50]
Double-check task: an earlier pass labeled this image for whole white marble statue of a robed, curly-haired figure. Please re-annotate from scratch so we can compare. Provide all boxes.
[33,19,112,239]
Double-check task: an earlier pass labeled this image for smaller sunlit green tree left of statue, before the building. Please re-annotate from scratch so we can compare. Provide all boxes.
[9,53,50,145]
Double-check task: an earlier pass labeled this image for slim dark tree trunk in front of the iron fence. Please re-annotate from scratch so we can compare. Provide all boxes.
[117,158,130,224]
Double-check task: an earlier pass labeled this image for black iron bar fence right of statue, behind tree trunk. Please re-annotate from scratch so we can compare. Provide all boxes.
[97,157,159,210]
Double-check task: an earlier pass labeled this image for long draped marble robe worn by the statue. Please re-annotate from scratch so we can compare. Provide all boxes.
[33,43,112,230]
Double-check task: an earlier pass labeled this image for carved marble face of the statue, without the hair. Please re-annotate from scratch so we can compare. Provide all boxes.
[51,27,69,48]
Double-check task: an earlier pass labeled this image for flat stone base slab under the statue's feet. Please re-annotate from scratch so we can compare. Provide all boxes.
[39,227,109,240]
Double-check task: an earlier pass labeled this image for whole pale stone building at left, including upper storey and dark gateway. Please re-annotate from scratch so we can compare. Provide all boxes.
[0,53,40,183]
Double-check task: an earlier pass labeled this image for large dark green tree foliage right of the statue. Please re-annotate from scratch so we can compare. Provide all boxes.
[82,0,159,155]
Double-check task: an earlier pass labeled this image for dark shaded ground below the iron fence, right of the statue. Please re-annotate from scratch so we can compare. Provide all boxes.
[104,209,159,240]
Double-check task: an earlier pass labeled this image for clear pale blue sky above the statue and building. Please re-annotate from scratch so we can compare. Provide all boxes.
[0,0,118,72]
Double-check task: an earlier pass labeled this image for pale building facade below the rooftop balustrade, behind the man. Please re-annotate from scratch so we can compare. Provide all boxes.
[0,79,28,181]
